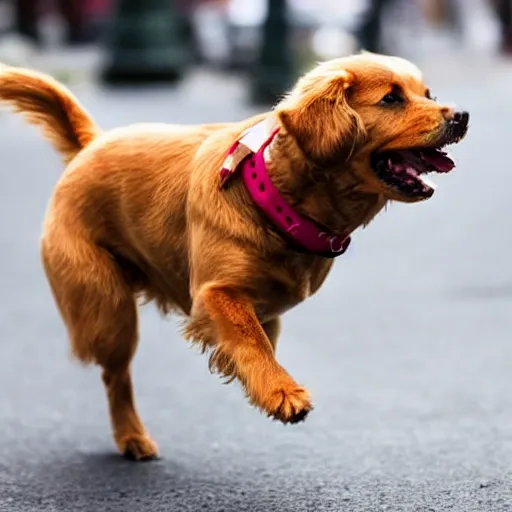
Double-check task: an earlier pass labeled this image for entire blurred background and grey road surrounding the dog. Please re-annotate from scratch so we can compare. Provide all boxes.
[0,0,512,512]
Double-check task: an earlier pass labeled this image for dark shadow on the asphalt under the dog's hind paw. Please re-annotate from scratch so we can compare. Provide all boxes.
[7,453,292,512]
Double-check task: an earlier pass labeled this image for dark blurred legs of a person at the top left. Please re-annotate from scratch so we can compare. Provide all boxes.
[14,0,88,45]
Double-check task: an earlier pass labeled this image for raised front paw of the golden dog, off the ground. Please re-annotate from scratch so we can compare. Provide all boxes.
[265,386,313,424]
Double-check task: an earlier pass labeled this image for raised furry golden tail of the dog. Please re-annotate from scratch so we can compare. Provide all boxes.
[0,64,100,163]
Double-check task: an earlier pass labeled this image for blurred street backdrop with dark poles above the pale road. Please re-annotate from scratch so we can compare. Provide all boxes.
[0,0,512,96]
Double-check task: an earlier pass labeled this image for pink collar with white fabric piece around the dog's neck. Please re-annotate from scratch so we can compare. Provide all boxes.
[220,118,350,258]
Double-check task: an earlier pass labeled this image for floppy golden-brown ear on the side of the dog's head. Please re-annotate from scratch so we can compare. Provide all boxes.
[276,70,366,165]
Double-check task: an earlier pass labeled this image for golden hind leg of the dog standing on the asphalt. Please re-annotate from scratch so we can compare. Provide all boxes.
[42,232,157,460]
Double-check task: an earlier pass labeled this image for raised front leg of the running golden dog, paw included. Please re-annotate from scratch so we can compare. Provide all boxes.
[186,285,312,423]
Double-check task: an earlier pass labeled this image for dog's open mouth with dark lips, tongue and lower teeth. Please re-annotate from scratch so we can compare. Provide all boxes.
[371,148,455,198]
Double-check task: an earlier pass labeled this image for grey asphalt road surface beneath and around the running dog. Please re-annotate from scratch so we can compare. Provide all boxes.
[0,61,512,512]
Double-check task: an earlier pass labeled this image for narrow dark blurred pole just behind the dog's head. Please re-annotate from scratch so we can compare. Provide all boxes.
[250,0,295,104]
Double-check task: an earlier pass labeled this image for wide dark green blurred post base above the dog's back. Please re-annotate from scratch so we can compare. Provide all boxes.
[102,0,189,83]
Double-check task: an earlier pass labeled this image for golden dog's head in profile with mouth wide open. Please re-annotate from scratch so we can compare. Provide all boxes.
[276,53,469,202]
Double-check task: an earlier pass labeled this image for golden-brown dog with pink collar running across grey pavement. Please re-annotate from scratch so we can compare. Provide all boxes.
[0,53,469,460]
